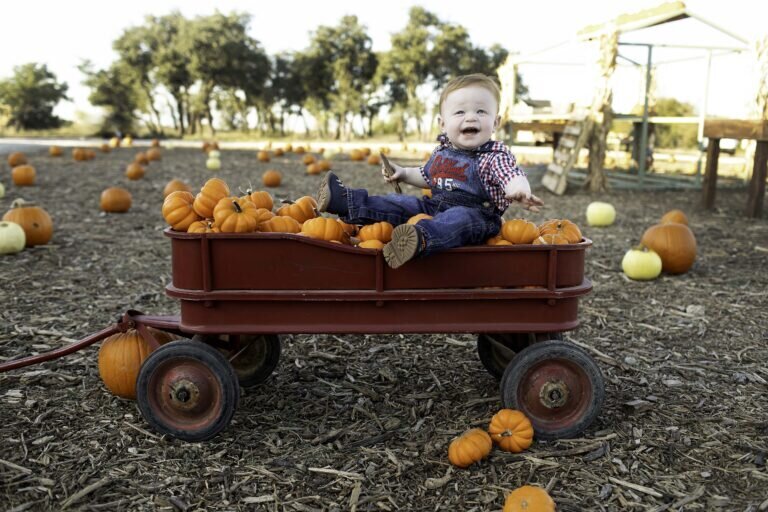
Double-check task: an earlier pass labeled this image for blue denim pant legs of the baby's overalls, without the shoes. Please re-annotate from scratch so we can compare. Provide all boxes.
[341,188,501,256]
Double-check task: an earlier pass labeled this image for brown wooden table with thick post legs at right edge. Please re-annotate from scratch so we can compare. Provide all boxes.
[702,119,768,217]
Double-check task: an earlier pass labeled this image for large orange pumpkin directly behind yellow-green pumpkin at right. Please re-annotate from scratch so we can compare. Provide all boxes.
[640,223,696,274]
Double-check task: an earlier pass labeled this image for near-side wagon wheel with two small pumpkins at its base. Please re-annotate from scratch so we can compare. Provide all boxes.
[501,340,605,439]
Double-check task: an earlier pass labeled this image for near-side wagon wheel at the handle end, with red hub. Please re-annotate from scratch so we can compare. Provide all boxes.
[136,340,240,441]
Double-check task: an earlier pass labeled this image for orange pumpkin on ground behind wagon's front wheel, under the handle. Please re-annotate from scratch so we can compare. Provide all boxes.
[99,327,175,400]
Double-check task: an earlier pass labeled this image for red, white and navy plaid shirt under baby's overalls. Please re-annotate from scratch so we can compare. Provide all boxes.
[421,135,527,213]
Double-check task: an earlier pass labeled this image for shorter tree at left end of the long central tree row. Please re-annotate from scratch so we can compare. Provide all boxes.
[79,61,144,135]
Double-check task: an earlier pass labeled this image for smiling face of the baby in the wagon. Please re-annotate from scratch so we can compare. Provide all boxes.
[440,85,500,149]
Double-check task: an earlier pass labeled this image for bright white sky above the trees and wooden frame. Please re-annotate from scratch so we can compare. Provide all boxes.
[0,0,768,124]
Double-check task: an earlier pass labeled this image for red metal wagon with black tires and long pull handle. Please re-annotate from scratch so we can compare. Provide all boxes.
[0,229,604,441]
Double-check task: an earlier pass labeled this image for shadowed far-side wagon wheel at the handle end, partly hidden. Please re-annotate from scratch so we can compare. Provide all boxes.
[192,334,280,388]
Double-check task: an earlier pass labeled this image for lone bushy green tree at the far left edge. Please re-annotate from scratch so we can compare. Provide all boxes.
[0,63,69,130]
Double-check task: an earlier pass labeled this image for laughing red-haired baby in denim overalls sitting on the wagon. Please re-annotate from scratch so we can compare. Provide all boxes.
[317,74,544,268]
